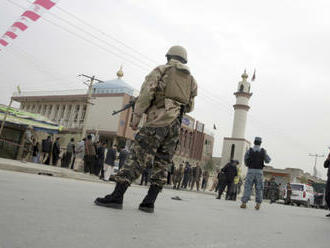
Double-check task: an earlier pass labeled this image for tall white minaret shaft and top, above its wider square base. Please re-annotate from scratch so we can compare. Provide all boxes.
[231,71,252,139]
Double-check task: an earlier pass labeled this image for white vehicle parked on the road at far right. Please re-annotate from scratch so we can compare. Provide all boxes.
[284,183,314,208]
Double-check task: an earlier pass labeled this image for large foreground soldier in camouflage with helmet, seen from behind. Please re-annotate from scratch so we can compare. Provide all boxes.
[95,46,197,212]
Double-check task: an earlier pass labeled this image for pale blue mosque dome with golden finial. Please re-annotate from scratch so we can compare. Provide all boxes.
[93,68,134,96]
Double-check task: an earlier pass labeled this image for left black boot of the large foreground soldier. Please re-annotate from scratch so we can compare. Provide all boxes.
[95,182,129,209]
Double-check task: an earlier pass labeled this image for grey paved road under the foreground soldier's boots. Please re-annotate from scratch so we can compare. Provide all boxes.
[0,170,330,248]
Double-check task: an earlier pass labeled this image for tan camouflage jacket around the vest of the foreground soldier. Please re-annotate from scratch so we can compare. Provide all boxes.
[133,59,197,127]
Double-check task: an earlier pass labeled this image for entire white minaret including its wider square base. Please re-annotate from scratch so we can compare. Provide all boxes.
[221,71,252,176]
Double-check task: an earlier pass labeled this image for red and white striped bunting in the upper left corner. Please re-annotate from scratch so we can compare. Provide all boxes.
[0,0,58,51]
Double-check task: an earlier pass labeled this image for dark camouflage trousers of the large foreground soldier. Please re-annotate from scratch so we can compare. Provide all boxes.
[115,119,181,187]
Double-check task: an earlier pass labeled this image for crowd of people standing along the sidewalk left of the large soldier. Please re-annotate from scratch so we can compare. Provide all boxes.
[22,131,128,181]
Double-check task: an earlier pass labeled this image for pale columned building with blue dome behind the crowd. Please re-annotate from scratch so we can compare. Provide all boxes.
[13,70,136,146]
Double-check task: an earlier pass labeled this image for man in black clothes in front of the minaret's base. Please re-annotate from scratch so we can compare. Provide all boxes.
[217,160,239,199]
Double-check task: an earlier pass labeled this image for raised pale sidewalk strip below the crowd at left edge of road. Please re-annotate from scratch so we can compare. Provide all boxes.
[0,158,102,182]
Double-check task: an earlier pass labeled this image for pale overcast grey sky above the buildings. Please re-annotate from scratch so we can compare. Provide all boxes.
[0,0,330,177]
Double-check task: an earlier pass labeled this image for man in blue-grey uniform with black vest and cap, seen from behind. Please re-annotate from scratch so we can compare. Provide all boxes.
[241,137,271,210]
